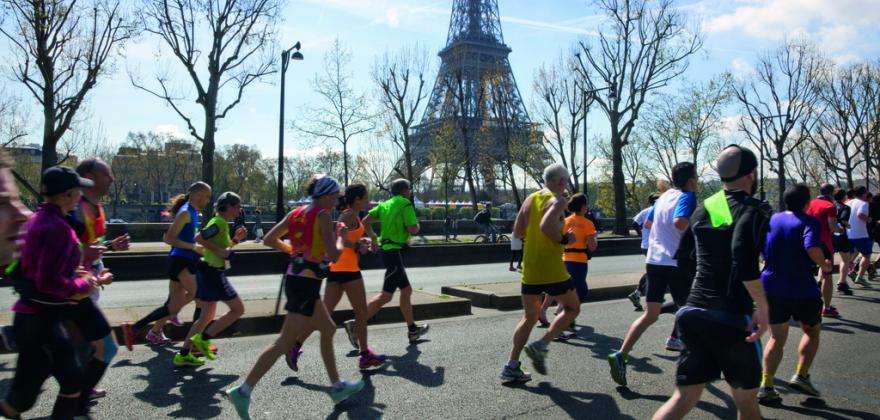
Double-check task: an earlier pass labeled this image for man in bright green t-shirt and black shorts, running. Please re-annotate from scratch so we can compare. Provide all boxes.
[364,179,428,343]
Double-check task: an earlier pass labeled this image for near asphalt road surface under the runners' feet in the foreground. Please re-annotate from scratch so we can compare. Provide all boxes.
[0,289,880,419]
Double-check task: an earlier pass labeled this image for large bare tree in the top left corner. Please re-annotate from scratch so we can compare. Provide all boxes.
[0,0,132,169]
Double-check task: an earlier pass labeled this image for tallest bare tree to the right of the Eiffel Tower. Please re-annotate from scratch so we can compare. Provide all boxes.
[578,0,703,235]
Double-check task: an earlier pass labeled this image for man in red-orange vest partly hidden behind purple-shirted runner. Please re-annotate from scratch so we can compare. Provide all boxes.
[68,158,130,404]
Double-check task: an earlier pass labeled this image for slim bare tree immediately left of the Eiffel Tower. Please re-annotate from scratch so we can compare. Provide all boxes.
[372,46,430,184]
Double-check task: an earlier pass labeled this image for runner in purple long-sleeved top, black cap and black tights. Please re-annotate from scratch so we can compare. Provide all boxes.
[0,166,109,419]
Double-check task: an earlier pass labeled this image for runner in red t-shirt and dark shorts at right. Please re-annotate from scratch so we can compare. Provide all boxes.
[807,183,840,315]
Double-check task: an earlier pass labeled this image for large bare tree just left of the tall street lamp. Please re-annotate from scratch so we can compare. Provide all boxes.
[131,0,281,184]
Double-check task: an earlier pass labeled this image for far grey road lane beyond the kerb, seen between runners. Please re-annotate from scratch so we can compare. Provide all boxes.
[0,255,645,308]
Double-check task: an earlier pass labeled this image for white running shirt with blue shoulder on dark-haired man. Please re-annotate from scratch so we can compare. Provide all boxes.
[645,189,697,266]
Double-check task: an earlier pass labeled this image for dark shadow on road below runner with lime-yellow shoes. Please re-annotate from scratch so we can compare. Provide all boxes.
[114,347,238,418]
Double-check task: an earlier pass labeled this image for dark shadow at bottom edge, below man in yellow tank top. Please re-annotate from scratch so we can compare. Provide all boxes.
[511,381,633,419]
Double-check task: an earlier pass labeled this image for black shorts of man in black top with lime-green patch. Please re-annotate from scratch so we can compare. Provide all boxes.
[675,307,762,389]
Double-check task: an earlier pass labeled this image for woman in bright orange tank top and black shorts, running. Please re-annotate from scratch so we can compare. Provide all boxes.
[286,184,385,371]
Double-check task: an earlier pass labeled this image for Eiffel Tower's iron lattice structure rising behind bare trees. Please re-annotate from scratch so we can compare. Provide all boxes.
[413,0,540,194]
